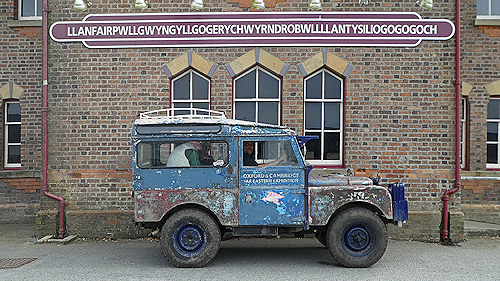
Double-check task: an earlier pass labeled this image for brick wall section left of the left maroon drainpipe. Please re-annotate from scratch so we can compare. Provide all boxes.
[0,0,42,223]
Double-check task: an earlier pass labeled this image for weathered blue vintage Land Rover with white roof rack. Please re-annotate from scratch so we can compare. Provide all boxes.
[132,109,408,267]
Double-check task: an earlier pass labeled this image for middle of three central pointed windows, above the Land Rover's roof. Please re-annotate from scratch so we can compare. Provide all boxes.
[233,66,281,125]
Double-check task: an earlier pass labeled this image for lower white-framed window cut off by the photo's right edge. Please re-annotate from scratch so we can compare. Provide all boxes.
[486,97,500,169]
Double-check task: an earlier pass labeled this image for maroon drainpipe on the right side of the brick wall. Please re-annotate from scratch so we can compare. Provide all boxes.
[441,0,462,242]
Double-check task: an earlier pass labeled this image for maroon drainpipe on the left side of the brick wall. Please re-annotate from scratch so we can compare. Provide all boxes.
[42,0,66,238]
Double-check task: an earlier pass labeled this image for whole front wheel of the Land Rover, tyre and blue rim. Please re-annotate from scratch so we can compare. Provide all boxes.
[327,208,388,267]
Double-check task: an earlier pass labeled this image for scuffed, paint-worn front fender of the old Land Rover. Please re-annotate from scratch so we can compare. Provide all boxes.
[309,185,393,226]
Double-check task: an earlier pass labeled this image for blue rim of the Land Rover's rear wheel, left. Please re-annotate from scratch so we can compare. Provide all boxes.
[173,223,207,257]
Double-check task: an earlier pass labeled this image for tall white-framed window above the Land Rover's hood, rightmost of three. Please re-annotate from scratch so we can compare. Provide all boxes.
[304,69,344,165]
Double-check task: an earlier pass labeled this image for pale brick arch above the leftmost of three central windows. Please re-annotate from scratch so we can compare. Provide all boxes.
[163,51,217,78]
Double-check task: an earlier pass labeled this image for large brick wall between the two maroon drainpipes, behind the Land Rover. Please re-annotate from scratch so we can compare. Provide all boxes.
[43,0,457,219]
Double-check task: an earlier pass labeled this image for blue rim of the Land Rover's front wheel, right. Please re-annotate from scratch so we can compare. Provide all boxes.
[342,224,375,257]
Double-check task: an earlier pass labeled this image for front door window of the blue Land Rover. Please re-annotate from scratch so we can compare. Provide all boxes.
[243,140,299,167]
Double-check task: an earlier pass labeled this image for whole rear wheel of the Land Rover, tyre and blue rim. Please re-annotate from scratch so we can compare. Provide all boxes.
[160,209,221,267]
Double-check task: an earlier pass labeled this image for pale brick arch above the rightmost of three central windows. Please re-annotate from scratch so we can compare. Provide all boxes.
[297,50,352,77]
